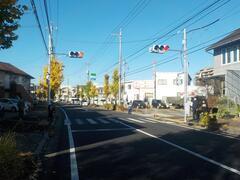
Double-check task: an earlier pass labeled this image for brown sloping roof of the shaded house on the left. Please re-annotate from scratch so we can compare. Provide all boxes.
[0,62,34,79]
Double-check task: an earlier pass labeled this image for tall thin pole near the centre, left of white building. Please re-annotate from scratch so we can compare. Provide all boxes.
[118,28,122,105]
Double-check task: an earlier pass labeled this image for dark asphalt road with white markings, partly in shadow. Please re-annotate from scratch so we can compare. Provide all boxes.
[42,106,240,180]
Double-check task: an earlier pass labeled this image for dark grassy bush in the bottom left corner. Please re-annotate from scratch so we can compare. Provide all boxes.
[0,133,24,180]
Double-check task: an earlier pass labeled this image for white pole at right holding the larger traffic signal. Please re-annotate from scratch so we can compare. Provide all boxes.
[183,29,189,123]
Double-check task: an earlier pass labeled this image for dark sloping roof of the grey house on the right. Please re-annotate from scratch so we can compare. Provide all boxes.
[206,28,240,51]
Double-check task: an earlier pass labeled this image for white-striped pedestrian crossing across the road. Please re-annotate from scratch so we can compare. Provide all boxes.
[74,117,159,125]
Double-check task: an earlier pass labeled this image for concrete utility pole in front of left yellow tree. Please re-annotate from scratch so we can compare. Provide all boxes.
[47,26,53,105]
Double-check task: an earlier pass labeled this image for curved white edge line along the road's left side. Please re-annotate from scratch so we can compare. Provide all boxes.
[60,108,79,180]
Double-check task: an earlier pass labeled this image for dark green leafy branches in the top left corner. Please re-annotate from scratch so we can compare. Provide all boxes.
[0,0,27,49]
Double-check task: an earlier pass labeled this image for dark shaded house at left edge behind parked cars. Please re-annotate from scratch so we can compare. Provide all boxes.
[0,62,33,100]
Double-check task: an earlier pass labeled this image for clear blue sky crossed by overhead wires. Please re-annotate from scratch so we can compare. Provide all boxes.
[0,0,240,86]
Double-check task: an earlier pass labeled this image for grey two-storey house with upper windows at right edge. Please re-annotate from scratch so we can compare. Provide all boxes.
[206,28,240,103]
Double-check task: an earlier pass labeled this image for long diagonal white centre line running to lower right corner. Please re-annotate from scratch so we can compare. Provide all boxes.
[113,118,240,175]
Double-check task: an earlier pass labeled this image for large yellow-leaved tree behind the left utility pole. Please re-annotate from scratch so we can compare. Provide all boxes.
[40,57,63,98]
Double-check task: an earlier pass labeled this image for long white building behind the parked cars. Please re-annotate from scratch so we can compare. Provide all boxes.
[123,72,202,102]
